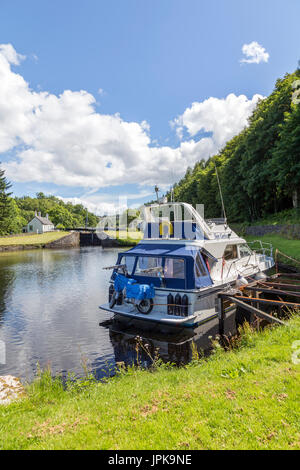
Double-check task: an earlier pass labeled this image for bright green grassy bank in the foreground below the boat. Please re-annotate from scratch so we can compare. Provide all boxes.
[0,317,300,449]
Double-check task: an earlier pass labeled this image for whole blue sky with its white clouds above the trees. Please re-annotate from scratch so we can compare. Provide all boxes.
[0,0,300,212]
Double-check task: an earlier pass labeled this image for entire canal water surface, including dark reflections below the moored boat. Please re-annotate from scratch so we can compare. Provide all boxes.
[0,247,233,381]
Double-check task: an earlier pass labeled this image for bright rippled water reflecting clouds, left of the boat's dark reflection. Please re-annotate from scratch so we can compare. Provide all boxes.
[0,248,125,380]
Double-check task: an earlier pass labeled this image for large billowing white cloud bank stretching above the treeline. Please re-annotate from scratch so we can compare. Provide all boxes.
[0,44,260,190]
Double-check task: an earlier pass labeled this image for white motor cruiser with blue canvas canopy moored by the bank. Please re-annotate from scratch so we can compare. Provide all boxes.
[101,203,274,327]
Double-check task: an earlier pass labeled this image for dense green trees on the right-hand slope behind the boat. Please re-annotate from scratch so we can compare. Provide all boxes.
[170,69,300,222]
